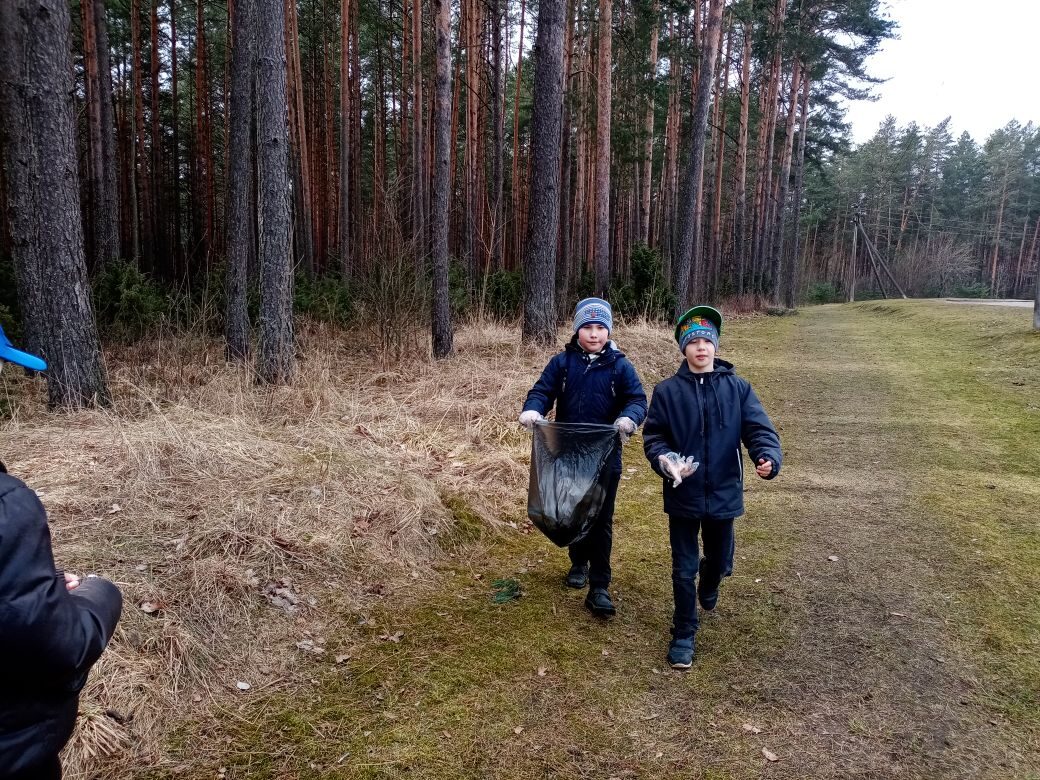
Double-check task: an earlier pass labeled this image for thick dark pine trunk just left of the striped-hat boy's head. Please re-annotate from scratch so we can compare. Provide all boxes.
[523,0,566,344]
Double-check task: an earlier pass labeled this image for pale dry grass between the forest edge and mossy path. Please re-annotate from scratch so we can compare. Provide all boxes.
[0,323,659,778]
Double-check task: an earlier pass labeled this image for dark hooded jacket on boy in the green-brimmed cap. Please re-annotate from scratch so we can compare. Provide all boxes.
[643,358,782,519]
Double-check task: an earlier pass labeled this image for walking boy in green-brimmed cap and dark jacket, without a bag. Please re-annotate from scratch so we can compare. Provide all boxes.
[643,306,782,669]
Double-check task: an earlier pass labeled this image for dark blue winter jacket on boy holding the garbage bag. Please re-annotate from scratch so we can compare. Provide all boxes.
[523,338,647,473]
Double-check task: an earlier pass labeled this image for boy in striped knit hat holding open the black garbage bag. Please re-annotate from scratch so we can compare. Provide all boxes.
[520,297,647,618]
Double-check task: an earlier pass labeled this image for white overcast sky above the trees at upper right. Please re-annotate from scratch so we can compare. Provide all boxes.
[848,0,1040,144]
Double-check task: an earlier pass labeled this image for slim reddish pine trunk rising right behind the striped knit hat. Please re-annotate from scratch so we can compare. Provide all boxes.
[594,0,614,296]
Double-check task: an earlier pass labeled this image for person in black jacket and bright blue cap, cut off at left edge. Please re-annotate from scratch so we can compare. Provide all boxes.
[0,329,123,780]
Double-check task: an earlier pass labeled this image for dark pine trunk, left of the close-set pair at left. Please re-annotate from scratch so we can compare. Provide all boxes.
[226,0,255,360]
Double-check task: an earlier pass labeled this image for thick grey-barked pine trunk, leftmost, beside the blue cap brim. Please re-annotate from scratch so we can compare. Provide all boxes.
[0,0,108,408]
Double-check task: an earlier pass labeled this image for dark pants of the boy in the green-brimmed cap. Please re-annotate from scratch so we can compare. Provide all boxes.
[668,515,733,639]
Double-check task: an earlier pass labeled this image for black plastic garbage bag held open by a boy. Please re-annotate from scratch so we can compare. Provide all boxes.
[527,422,621,547]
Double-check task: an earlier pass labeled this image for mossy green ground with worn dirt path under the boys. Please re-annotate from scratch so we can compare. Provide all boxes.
[8,302,1040,780]
